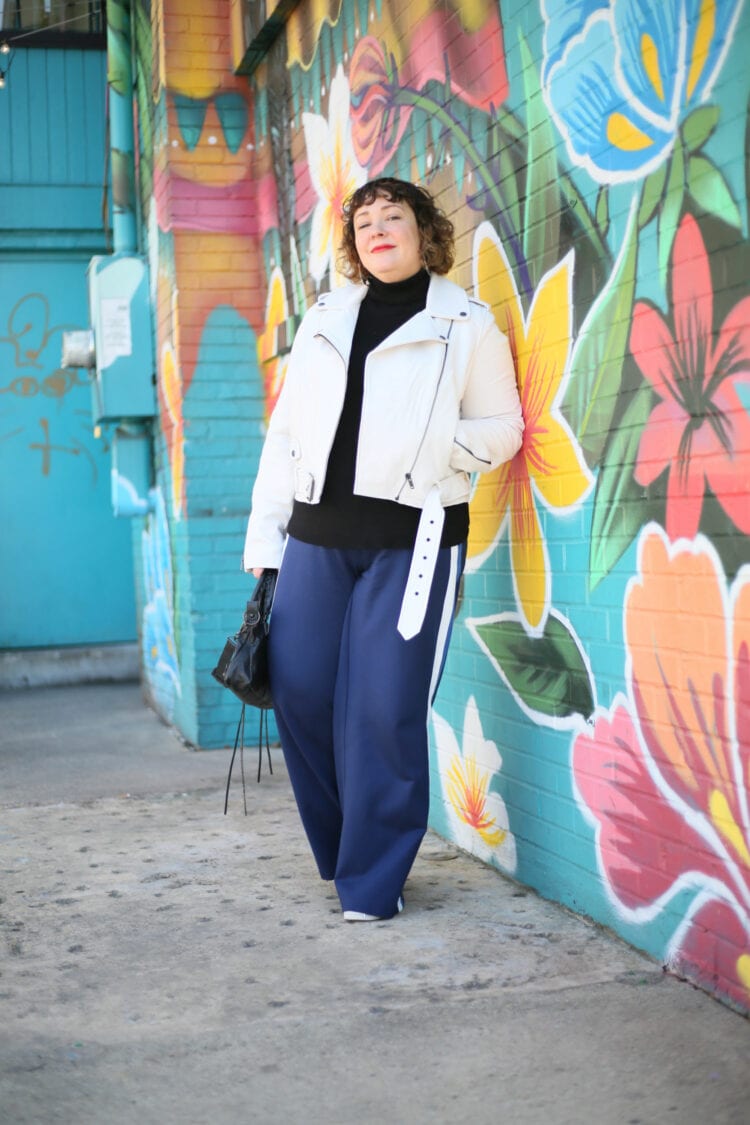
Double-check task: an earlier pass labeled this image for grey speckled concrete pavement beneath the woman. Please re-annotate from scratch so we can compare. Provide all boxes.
[0,684,750,1125]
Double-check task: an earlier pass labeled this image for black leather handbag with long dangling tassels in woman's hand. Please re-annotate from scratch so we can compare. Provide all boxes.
[211,569,279,813]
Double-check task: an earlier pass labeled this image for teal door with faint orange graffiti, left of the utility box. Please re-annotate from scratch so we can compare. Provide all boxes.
[0,255,136,649]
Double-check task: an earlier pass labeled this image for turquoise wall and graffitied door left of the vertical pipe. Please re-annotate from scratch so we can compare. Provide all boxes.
[0,50,136,648]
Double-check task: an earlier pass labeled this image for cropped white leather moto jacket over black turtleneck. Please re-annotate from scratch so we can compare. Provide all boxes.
[244,267,523,570]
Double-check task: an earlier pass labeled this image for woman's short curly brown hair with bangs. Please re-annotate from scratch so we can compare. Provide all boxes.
[336,176,455,281]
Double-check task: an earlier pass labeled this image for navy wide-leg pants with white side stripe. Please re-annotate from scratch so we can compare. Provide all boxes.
[270,539,466,918]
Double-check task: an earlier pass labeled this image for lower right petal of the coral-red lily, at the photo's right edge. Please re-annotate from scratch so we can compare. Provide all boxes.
[701,374,750,536]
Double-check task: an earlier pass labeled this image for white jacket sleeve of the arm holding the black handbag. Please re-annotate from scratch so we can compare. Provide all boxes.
[243,351,295,570]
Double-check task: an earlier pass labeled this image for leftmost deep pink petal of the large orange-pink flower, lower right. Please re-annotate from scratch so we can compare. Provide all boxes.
[572,705,724,910]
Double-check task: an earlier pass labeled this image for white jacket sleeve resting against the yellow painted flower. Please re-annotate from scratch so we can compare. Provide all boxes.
[451,308,524,473]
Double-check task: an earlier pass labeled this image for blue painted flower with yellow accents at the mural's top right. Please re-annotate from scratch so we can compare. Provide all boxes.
[542,0,742,183]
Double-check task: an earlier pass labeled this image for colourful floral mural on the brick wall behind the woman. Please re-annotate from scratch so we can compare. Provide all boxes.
[139,0,750,1010]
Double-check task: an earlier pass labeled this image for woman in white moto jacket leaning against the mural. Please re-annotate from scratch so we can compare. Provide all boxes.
[244,178,523,921]
